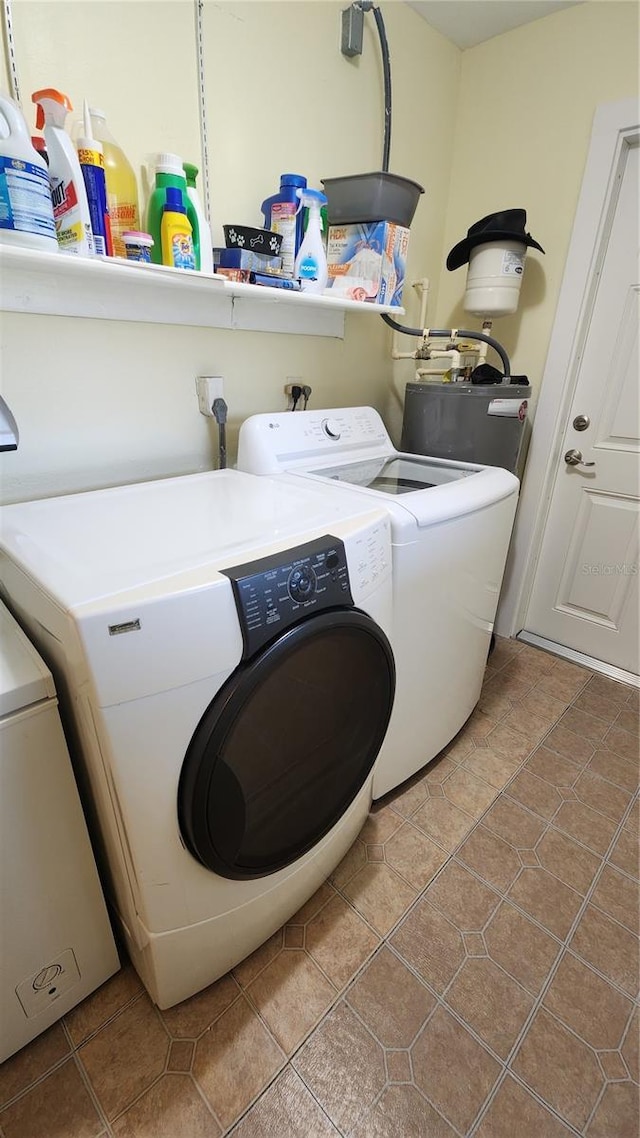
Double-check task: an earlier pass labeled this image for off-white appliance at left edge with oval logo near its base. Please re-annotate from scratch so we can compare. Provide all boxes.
[0,604,120,1063]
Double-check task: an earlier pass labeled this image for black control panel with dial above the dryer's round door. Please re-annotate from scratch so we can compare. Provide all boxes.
[222,534,353,660]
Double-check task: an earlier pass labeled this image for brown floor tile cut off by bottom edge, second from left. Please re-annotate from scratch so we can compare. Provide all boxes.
[114,1074,217,1138]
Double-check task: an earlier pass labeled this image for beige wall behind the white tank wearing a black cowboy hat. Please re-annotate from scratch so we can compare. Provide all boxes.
[437,0,640,399]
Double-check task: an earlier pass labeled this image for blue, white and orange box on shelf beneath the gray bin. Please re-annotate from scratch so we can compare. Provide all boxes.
[327,221,409,305]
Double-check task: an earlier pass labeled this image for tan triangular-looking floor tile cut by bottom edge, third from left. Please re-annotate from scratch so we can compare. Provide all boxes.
[227,1067,339,1138]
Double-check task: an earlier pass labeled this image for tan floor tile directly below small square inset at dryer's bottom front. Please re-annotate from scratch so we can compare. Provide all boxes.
[247,949,336,1055]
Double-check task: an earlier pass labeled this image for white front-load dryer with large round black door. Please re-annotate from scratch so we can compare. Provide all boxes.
[0,470,395,1007]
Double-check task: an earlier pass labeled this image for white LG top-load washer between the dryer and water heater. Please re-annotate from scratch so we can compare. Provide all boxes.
[238,407,519,799]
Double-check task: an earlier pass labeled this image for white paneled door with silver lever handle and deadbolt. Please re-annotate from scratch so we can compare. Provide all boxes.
[525,138,640,674]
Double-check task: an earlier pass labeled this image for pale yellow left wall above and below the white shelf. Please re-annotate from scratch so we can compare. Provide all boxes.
[0,0,461,501]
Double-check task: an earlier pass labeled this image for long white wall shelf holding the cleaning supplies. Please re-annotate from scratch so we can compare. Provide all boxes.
[0,245,404,337]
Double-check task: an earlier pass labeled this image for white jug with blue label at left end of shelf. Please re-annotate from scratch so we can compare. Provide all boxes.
[0,94,58,253]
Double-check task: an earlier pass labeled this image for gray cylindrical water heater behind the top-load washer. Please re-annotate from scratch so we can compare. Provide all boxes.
[401,384,531,477]
